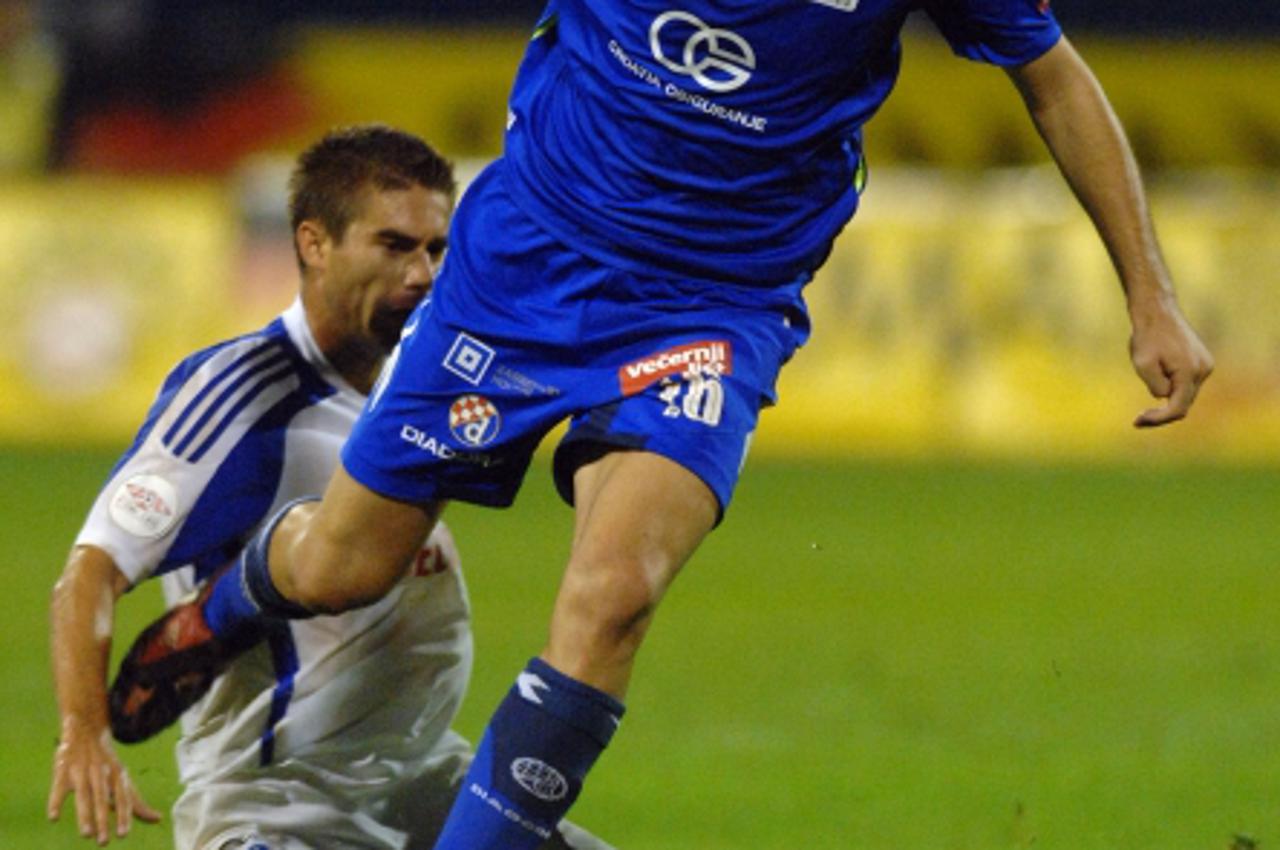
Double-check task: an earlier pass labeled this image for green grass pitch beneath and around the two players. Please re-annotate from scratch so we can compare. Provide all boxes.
[0,452,1280,850]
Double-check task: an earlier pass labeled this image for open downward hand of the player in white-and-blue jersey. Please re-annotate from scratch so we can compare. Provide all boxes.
[49,723,160,846]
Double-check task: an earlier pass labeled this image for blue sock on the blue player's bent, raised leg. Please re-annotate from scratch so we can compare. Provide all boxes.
[202,499,316,640]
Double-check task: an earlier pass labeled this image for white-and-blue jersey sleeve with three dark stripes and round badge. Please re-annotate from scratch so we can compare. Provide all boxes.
[76,335,300,585]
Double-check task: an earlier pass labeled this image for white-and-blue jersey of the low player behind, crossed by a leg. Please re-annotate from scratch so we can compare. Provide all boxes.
[77,302,471,844]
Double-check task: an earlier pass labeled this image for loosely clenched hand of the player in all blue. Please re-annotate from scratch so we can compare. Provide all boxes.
[1129,298,1213,428]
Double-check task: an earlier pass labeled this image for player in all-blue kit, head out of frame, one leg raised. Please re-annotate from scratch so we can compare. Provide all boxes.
[110,0,1212,850]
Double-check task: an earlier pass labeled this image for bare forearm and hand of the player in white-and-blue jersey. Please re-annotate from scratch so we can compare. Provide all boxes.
[49,545,160,845]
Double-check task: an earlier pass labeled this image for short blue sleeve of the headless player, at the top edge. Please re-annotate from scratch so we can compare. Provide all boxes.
[924,0,1062,67]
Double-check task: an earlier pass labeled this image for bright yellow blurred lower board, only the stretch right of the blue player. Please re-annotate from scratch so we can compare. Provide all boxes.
[758,169,1280,460]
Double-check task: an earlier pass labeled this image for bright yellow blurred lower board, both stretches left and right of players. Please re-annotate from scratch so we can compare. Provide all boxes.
[0,169,1280,460]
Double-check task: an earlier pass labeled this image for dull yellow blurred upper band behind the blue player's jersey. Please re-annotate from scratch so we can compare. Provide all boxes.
[282,26,1280,169]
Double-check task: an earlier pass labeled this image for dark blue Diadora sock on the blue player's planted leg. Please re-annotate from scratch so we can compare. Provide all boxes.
[435,658,623,850]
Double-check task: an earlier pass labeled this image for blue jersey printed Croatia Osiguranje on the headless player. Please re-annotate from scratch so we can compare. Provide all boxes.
[506,0,1061,287]
